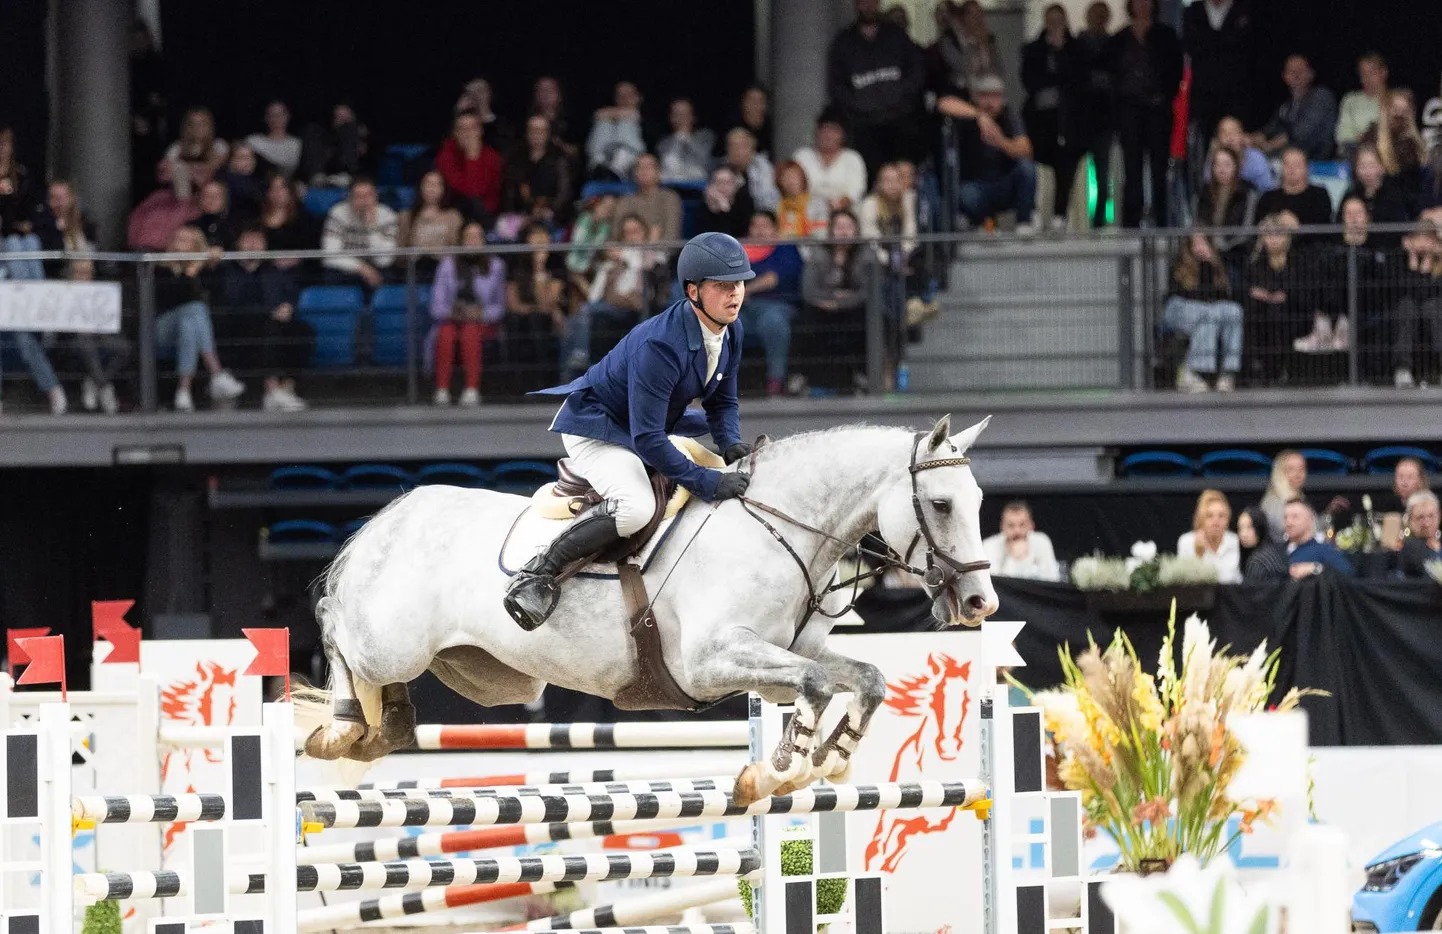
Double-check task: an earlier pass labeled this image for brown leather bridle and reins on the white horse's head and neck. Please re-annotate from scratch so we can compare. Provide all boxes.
[737,431,991,639]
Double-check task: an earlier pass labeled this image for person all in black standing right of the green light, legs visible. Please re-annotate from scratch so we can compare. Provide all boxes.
[1107,0,1182,228]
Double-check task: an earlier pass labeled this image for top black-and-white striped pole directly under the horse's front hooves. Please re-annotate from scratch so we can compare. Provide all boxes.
[300,778,986,827]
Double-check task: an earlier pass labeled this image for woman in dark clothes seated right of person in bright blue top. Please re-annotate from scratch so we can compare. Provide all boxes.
[795,209,875,395]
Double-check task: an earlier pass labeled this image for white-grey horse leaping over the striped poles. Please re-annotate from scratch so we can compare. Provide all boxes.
[297,417,996,801]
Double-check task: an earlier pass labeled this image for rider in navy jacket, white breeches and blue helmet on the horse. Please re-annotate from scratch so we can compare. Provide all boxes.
[505,234,756,631]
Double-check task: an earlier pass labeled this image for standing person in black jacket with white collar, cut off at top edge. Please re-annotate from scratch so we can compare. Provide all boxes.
[1181,0,1256,140]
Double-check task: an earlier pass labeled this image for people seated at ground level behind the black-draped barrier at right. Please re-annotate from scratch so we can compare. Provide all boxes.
[982,450,1442,584]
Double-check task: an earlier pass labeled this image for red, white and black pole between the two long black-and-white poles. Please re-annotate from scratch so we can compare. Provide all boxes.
[296,817,738,866]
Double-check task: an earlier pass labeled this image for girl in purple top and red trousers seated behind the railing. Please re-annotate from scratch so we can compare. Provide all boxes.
[425,221,506,406]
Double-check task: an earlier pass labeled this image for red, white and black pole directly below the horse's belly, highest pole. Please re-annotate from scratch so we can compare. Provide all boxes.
[415,721,748,750]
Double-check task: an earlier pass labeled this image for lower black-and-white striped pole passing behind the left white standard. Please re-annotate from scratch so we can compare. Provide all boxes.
[74,849,761,901]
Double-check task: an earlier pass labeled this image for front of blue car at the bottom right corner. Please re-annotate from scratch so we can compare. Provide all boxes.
[1353,823,1442,934]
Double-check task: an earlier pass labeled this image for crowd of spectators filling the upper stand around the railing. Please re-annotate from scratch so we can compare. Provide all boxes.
[0,0,1442,412]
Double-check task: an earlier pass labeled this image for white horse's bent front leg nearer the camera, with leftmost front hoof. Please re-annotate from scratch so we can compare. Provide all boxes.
[686,630,833,806]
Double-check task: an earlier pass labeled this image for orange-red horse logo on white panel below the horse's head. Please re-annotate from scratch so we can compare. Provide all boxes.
[865,654,972,872]
